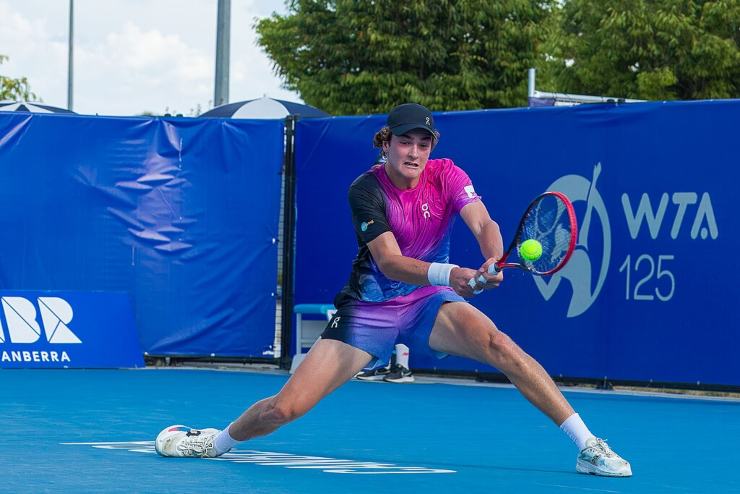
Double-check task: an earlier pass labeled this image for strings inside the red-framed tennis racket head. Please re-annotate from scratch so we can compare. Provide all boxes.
[520,196,574,273]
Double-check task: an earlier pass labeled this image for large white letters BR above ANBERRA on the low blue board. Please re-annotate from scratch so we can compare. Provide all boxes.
[0,297,82,344]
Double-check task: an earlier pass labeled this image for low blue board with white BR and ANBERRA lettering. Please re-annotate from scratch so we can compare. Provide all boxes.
[0,290,144,369]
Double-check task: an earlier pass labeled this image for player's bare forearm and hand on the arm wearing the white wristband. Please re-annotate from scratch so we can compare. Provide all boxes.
[367,231,477,297]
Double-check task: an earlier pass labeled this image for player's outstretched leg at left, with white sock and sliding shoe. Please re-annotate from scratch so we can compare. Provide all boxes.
[155,339,372,457]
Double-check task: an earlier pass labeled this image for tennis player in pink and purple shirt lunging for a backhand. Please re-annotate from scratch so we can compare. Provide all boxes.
[155,103,632,477]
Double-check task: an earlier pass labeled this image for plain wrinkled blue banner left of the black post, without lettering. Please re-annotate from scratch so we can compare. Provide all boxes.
[0,113,284,357]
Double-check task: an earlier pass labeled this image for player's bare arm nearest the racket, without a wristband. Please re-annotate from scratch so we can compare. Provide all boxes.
[460,201,504,288]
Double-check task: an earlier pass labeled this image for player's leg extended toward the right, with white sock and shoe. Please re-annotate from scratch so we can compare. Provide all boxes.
[429,302,632,477]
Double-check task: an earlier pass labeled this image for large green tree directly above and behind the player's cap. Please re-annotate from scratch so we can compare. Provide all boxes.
[256,0,555,115]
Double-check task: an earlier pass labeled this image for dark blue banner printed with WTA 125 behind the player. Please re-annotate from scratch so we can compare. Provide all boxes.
[296,100,740,385]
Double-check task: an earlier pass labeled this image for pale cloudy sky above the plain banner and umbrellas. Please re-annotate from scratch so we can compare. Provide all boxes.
[0,0,302,115]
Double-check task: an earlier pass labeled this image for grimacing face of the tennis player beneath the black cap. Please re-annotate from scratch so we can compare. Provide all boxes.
[383,130,433,188]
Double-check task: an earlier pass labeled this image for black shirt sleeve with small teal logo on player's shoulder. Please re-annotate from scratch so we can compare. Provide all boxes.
[349,174,391,244]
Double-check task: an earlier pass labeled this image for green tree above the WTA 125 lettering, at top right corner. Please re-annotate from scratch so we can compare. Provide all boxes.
[538,0,740,100]
